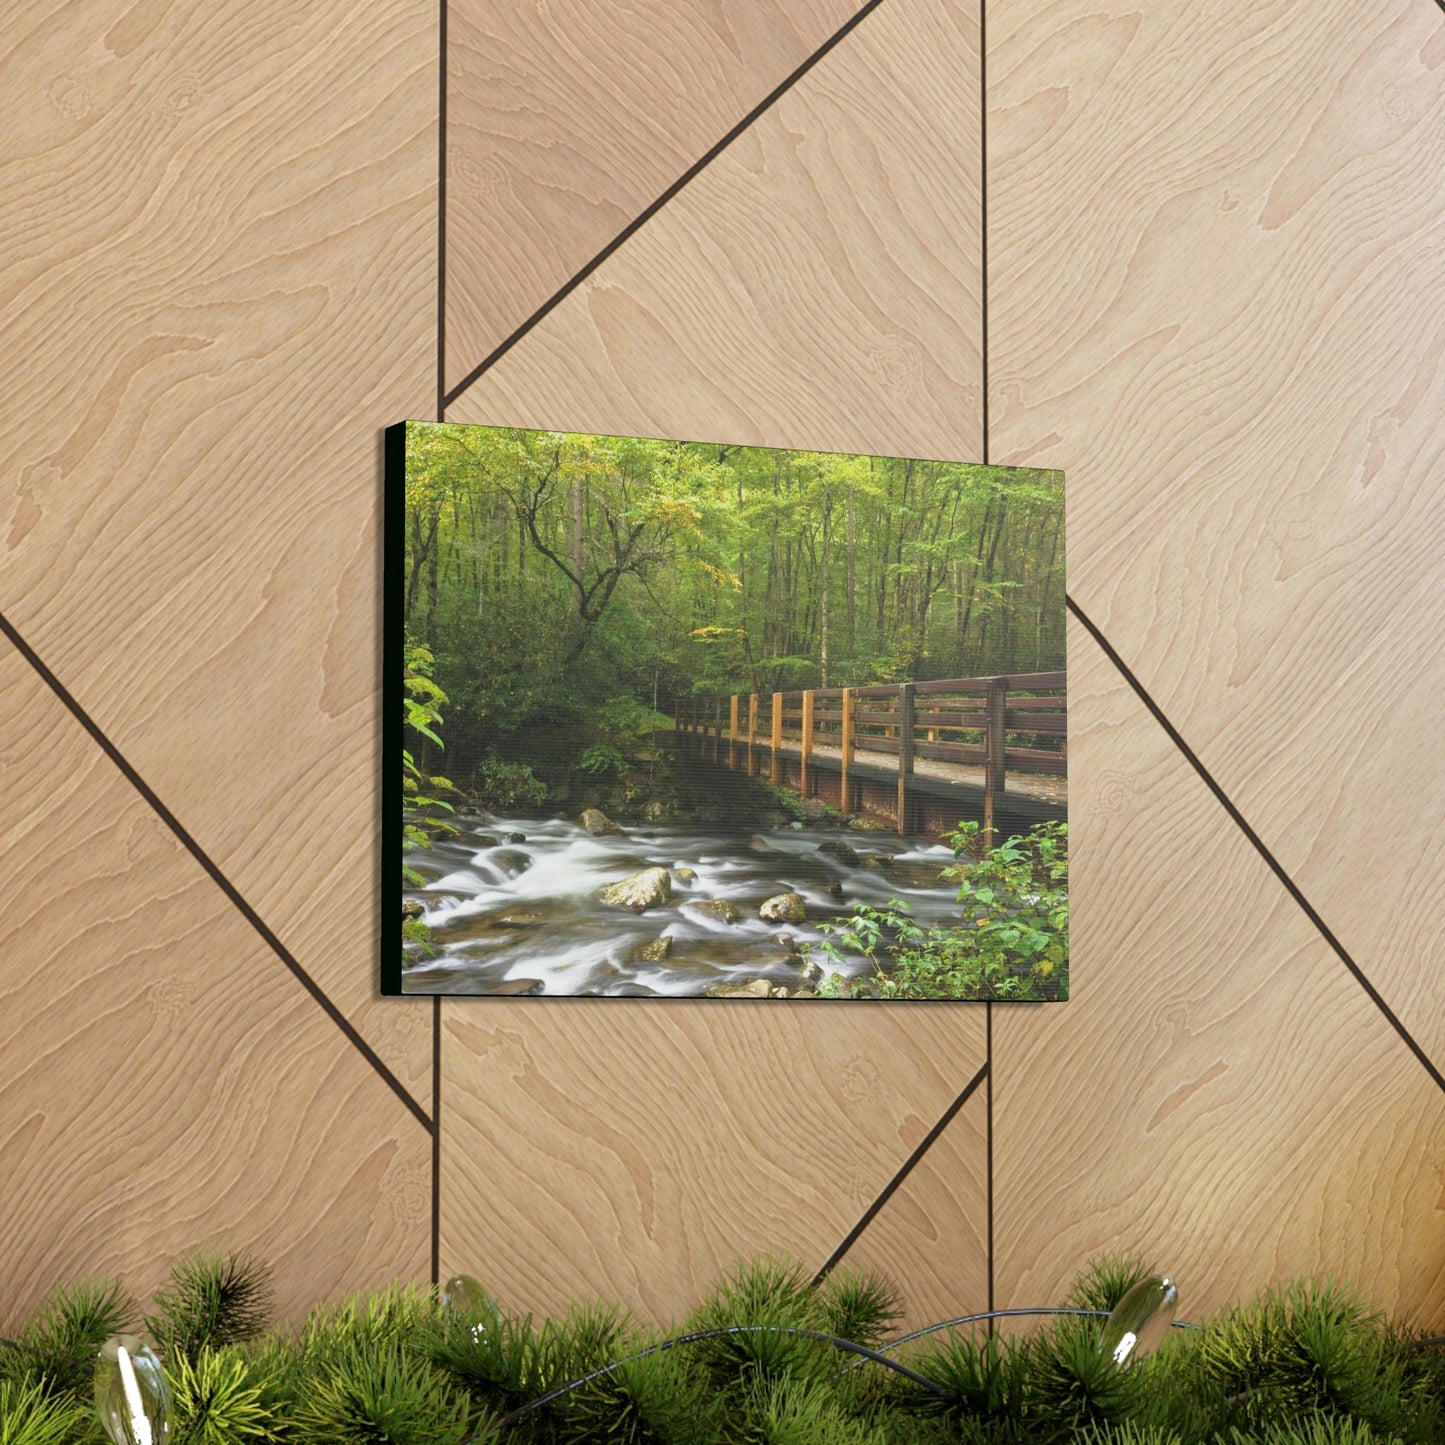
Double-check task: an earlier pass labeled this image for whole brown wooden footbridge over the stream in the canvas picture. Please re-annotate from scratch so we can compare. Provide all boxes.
[675,672,1068,834]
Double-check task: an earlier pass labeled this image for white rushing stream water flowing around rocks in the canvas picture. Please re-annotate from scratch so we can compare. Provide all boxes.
[403,816,958,996]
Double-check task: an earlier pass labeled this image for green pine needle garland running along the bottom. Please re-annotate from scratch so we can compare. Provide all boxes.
[0,1254,1445,1445]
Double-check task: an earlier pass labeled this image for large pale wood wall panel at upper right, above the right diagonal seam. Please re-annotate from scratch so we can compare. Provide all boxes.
[988,0,1445,1066]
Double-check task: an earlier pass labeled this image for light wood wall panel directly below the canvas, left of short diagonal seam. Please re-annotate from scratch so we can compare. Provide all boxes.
[441,1000,984,1321]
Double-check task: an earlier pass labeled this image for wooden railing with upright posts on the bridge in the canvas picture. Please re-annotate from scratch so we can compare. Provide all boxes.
[675,672,1068,831]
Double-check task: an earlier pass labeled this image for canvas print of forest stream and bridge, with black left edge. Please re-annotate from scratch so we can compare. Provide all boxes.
[383,422,1069,1007]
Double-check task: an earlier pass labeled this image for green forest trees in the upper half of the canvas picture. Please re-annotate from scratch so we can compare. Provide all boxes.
[403,422,1065,795]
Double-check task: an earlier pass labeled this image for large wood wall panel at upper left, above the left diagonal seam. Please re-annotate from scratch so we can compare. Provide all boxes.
[0,0,436,1103]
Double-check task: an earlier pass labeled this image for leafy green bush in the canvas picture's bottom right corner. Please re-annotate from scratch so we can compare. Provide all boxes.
[811,822,1069,1001]
